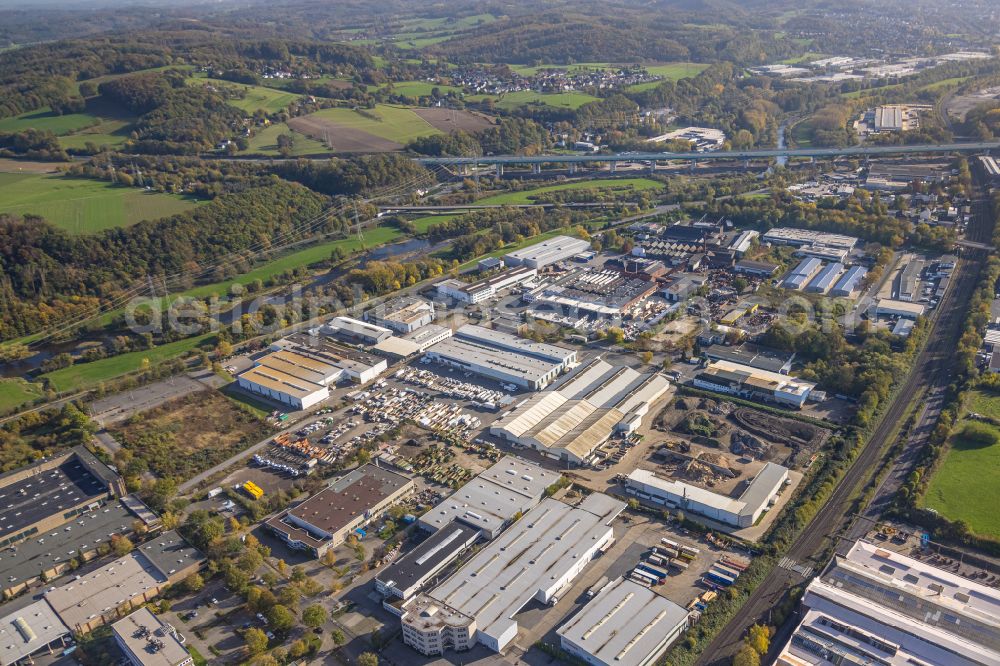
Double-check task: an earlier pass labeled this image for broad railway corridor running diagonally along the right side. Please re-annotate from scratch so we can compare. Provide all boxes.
[697,192,992,665]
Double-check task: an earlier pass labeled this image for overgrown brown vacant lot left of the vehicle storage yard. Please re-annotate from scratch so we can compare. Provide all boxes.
[114,391,269,479]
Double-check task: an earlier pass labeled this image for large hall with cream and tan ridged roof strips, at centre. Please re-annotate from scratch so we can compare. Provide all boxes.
[490,359,670,465]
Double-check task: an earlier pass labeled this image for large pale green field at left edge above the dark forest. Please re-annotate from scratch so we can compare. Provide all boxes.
[0,173,201,234]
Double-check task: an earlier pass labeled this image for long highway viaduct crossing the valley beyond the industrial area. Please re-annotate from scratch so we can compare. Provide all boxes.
[414,141,1000,168]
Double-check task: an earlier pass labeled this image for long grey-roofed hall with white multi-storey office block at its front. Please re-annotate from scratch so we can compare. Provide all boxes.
[401,493,625,656]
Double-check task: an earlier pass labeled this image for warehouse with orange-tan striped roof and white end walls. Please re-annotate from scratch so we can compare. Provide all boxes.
[236,334,389,410]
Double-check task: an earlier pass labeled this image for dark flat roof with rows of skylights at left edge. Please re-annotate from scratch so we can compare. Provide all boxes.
[0,456,108,539]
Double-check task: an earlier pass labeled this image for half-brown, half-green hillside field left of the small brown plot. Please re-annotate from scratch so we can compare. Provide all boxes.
[288,104,439,153]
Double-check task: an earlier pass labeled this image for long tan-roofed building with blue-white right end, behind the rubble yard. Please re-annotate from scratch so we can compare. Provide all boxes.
[692,361,816,409]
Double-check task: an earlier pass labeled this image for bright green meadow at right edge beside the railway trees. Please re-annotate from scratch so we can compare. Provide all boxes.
[920,420,1000,539]
